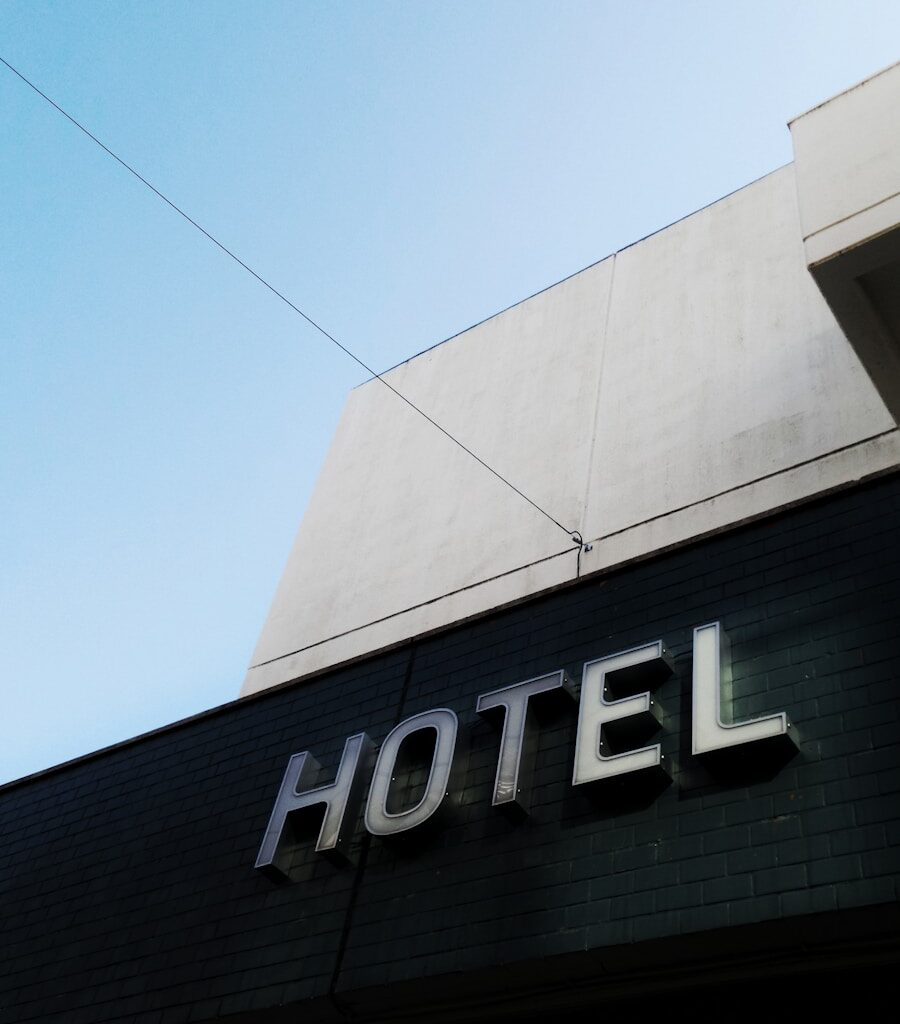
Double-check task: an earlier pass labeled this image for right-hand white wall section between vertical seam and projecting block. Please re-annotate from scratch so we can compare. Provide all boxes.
[584,167,892,537]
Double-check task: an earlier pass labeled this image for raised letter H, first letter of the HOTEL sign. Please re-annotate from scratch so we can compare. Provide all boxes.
[255,732,375,879]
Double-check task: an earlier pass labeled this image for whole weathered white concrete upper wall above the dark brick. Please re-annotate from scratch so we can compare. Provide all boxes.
[242,66,900,694]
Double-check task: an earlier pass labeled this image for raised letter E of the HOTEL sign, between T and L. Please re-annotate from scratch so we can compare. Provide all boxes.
[572,640,672,785]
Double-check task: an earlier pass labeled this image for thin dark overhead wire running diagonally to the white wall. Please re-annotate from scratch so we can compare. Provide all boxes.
[0,55,583,547]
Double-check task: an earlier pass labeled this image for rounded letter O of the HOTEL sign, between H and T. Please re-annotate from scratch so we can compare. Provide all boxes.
[366,708,459,836]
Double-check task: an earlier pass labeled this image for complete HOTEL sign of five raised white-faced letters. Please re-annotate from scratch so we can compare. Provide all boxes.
[256,623,792,878]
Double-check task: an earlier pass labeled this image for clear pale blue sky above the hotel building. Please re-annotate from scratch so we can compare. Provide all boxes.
[0,0,900,781]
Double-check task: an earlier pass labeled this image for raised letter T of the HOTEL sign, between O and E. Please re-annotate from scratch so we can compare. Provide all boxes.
[475,672,574,813]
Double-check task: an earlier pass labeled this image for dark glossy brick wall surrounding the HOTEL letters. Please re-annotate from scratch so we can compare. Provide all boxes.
[0,476,900,1024]
